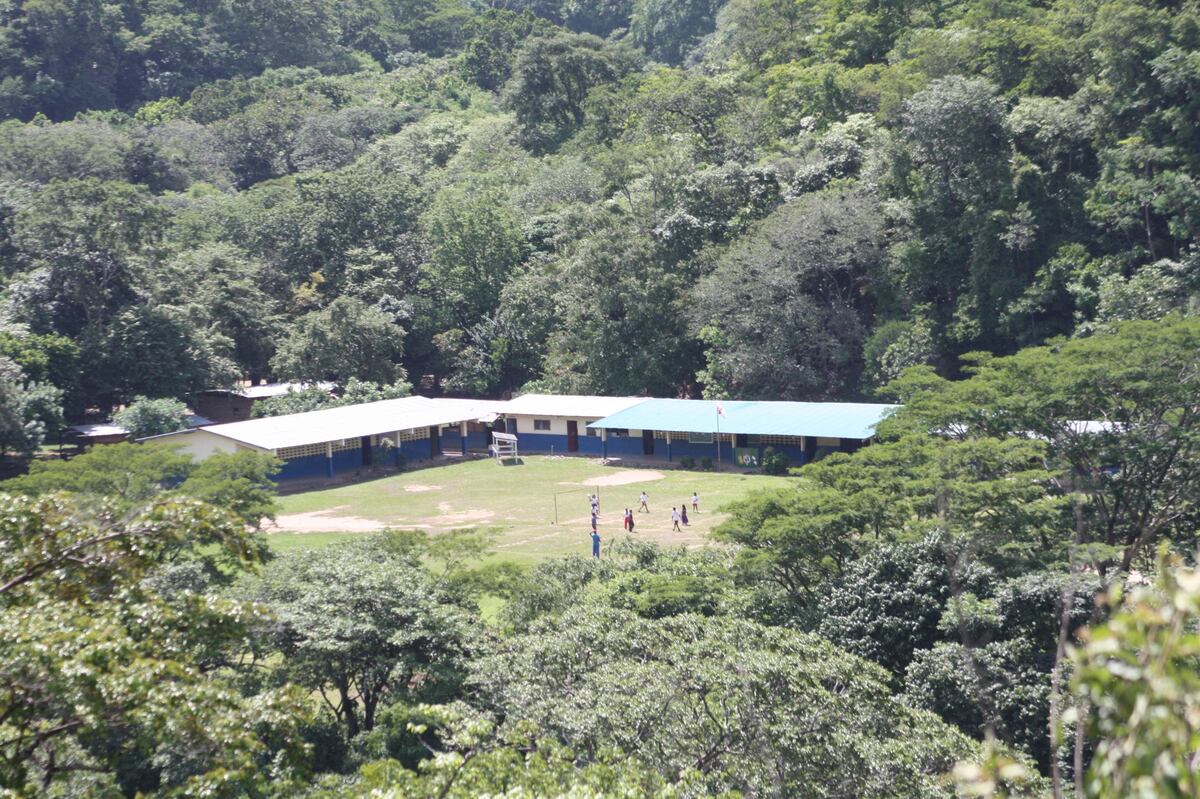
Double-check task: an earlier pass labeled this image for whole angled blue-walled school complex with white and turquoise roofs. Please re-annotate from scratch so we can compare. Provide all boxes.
[155,395,896,480]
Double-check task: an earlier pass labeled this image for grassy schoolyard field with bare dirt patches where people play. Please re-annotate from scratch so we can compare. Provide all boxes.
[269,456,794,561]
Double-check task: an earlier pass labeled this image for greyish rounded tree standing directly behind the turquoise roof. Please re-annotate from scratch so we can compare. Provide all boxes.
[691,188,884,400]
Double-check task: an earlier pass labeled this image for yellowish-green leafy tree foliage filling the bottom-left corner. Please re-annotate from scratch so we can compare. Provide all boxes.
[0,494,307,797]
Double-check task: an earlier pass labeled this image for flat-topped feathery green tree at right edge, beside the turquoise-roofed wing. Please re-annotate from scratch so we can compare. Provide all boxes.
[883,319,1200,573]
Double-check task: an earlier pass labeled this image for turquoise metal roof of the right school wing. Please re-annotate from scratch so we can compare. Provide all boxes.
[588,400,899,439]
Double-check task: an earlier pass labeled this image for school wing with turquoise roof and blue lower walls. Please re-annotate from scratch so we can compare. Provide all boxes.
[585,400,899,468]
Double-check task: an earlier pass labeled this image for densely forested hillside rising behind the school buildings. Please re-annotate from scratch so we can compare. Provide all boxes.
[0,0,1200,431]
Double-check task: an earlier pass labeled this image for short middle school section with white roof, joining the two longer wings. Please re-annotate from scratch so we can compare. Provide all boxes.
[502,394,646,457]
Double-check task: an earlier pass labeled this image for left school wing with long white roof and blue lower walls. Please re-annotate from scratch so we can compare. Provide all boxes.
[154,397,505,480]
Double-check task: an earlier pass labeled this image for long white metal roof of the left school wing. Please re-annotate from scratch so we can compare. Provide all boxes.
[180,397,503,450]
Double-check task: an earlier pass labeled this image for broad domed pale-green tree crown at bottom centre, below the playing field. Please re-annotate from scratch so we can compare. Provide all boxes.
[470,607,988,797]
